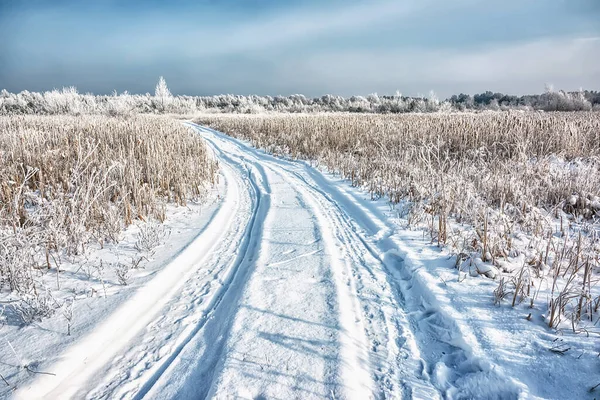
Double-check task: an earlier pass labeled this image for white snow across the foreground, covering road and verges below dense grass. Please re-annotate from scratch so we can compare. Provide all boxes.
[0,117,600,399]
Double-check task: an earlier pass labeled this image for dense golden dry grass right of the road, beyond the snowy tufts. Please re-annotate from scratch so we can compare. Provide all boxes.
[198,113,600,216]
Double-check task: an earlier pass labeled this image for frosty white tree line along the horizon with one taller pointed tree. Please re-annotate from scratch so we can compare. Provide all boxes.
[0,77,600,115]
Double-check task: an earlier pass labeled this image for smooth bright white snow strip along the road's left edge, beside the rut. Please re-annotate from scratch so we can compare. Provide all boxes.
[15,155,248,400]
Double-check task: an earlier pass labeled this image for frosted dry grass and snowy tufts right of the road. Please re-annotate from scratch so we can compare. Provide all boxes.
[197,112,600,333]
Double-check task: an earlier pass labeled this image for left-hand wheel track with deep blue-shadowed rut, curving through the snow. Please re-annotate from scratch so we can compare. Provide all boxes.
[81,138,270,399]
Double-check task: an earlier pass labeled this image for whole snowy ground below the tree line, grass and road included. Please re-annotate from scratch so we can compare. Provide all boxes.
[0,112,600,399]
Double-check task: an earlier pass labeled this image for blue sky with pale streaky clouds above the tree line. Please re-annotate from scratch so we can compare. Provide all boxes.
[0,0,600,97]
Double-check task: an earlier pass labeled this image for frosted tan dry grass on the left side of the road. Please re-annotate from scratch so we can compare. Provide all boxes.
[0,116,217,310]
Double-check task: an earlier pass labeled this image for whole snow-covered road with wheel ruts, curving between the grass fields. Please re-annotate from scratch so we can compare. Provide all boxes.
[16,125,525,399]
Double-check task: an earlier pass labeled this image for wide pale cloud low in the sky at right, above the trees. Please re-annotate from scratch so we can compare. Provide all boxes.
[278,37,600,95]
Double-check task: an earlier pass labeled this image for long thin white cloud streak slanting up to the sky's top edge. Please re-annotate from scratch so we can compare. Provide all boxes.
[106,0,475,58]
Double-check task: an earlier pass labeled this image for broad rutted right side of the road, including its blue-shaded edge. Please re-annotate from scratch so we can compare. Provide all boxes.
[197,123,522,398]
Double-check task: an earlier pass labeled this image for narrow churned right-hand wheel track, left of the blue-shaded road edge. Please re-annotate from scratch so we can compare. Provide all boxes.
[276,165,441,399]
